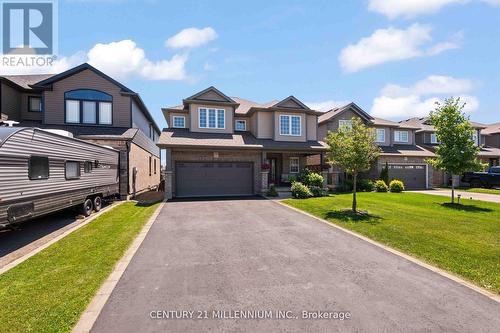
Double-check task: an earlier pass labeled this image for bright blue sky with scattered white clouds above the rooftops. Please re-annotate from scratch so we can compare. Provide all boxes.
[3,0,500,127]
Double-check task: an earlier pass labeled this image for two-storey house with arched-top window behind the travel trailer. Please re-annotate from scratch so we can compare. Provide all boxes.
[0,64,161,197]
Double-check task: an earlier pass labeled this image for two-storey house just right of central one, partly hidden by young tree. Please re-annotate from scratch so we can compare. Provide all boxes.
[308,103,435,189]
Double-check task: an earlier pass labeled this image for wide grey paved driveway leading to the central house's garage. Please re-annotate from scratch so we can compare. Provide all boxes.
[93,199,500,332]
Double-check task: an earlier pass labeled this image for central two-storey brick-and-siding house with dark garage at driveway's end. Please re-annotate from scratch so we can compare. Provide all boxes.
[158,87,326,198]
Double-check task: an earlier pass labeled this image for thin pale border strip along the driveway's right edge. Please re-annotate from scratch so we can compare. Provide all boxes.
[271,200,500,303]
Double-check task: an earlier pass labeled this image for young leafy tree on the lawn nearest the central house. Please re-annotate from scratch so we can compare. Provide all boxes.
[326,118,380,213]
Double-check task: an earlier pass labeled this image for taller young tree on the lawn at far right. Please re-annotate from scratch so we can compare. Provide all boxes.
[427,97,484,203]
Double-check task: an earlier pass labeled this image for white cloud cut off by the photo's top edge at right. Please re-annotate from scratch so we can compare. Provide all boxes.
[368,0,468,19]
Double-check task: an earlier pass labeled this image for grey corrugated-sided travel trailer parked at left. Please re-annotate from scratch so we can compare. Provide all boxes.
[0,127,119,229]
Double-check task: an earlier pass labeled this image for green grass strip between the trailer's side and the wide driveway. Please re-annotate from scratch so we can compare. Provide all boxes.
[0,203,158,332]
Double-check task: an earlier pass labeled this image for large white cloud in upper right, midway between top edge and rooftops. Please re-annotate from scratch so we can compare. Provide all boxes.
[338,24,461,72]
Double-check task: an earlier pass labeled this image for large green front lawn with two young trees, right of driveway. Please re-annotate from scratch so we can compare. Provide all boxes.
[284,193,500,293]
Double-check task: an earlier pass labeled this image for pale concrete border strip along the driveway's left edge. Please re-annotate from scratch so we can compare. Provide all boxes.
[72,201,166,333]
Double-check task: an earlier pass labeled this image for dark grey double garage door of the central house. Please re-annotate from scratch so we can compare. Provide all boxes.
[175,162,253,197]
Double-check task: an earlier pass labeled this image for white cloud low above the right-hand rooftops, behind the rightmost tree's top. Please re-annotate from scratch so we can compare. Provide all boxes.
[371,75,479,119]
